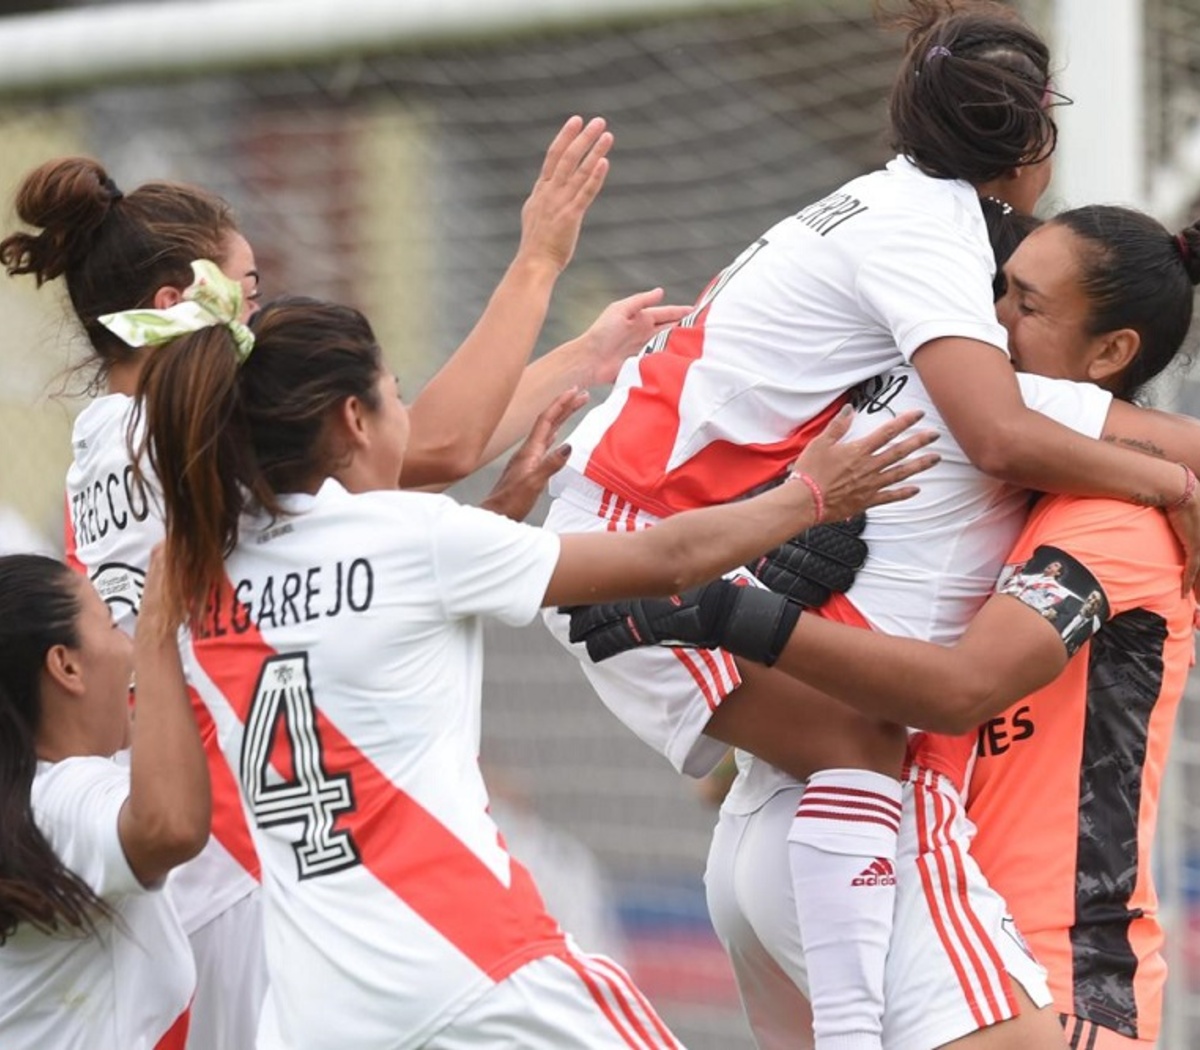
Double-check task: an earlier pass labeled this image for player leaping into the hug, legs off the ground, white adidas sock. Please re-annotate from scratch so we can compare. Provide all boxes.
[547,0,1200,1050]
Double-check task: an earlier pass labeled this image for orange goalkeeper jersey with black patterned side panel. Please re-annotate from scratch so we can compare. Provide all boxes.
[967,496,1194,1040]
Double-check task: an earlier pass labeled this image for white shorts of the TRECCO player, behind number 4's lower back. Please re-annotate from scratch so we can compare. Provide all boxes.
[187,889,266,1050]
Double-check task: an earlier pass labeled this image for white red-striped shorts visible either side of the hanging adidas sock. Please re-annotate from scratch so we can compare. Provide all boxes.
[704,770,1050,1050]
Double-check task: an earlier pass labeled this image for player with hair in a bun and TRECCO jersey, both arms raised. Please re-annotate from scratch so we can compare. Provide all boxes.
[0,118,683,1050]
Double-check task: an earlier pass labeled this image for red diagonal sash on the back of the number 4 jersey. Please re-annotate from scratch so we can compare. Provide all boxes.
[192,580,566,980]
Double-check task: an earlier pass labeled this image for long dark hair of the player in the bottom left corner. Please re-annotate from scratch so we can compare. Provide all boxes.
[0,554,108,944]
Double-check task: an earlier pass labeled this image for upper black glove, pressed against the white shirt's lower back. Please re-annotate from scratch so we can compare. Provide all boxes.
[746,514,868,608]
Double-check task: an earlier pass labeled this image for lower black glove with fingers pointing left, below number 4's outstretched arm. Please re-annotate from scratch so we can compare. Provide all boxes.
[560,580,802,667]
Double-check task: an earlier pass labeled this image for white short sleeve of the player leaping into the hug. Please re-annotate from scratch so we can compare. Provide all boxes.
[856,220,1008,361]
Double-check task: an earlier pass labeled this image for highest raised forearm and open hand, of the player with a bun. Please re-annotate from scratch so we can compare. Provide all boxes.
[400,116,612,488]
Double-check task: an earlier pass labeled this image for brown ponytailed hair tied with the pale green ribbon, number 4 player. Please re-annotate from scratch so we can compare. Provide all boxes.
[134,298,383,618]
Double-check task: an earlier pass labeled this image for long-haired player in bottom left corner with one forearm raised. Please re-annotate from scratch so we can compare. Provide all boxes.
[0,554,209,1050]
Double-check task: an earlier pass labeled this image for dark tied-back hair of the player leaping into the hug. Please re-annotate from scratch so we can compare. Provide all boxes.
[876,0,1057,186]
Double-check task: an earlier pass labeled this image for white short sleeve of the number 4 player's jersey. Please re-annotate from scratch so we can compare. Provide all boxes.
[433,499,559,626]
